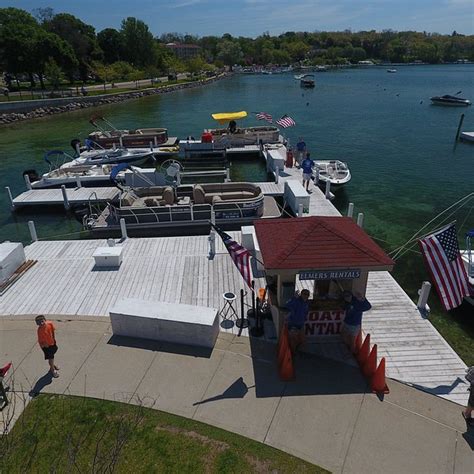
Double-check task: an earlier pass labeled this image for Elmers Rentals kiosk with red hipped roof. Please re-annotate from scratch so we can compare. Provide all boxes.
[254,217,394,337]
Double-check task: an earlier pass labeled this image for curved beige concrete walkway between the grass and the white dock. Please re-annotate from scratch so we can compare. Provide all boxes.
[0,316,474,473]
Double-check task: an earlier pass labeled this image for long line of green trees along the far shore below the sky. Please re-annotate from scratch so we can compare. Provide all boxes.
[0,8,474,88]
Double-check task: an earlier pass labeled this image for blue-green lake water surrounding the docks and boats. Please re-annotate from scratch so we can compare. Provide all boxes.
[0,65,474,304]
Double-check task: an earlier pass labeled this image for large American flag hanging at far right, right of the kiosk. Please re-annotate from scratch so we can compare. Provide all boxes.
[420,224,471,311]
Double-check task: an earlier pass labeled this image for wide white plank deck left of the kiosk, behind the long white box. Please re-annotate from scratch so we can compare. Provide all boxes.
[0,237,264,340]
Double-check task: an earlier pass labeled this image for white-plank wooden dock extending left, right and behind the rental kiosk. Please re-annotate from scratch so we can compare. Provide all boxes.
[0,151,468,405]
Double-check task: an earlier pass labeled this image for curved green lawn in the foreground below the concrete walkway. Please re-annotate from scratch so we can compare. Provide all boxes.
[0,394,328,473]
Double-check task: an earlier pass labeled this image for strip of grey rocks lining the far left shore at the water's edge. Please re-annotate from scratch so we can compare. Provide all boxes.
[0,73,229,126]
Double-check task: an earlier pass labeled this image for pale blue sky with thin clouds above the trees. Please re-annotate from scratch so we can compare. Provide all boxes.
[0,0,474,37]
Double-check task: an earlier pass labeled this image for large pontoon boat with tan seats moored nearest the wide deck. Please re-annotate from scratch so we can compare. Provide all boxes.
[84,183,281,234]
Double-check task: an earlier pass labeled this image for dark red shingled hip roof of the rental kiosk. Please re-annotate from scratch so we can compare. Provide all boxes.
[254,216,394,270]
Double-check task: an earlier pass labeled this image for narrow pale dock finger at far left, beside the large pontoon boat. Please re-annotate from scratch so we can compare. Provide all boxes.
[11,187,120,210]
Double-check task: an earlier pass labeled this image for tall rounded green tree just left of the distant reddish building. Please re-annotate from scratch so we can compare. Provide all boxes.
[120,17,156,67]
